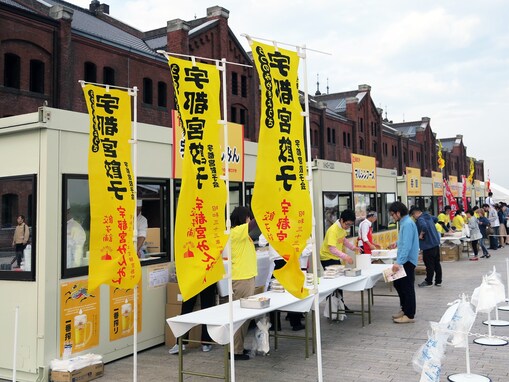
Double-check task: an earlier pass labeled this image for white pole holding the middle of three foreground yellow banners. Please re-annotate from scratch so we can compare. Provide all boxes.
[217,58,235,382]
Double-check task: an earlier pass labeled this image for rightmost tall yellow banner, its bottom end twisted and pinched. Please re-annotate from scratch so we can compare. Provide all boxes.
[252,42,312,298]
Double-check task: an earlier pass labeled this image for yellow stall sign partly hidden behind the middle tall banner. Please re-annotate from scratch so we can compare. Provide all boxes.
[172,110,244,182]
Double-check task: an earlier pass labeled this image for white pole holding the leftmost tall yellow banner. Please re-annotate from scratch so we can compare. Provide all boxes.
[129,86,139,382]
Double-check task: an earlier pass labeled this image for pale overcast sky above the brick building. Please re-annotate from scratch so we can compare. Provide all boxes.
[71,0,509,190]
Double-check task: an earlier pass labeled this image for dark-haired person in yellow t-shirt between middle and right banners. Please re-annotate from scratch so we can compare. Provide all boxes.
[230,206,258,361]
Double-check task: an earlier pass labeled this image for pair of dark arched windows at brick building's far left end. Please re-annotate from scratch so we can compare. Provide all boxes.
[4,53,44,94]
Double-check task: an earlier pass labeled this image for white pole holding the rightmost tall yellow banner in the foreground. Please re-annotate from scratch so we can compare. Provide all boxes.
[298,45,323,382]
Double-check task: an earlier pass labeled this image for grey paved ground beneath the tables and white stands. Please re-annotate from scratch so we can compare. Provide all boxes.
[100,246,509,382]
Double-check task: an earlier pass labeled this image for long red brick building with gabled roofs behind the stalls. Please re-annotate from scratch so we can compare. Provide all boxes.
[0,0,484,180]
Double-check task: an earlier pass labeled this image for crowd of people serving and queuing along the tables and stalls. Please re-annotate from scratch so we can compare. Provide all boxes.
[170,195,509,360]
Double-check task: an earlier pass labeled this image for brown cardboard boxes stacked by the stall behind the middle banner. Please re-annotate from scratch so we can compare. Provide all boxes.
[164,283,201,348]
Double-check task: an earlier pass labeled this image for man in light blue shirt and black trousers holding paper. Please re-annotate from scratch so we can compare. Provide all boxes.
[389,202,419,324]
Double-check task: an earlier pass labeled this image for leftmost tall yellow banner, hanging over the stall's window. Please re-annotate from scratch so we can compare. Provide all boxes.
[83,84,141,292]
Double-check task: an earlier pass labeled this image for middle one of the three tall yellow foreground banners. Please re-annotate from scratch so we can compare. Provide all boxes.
[168,57,227,300]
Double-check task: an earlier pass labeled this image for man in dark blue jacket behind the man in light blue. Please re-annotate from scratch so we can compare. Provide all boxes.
[410,206,442,288]
